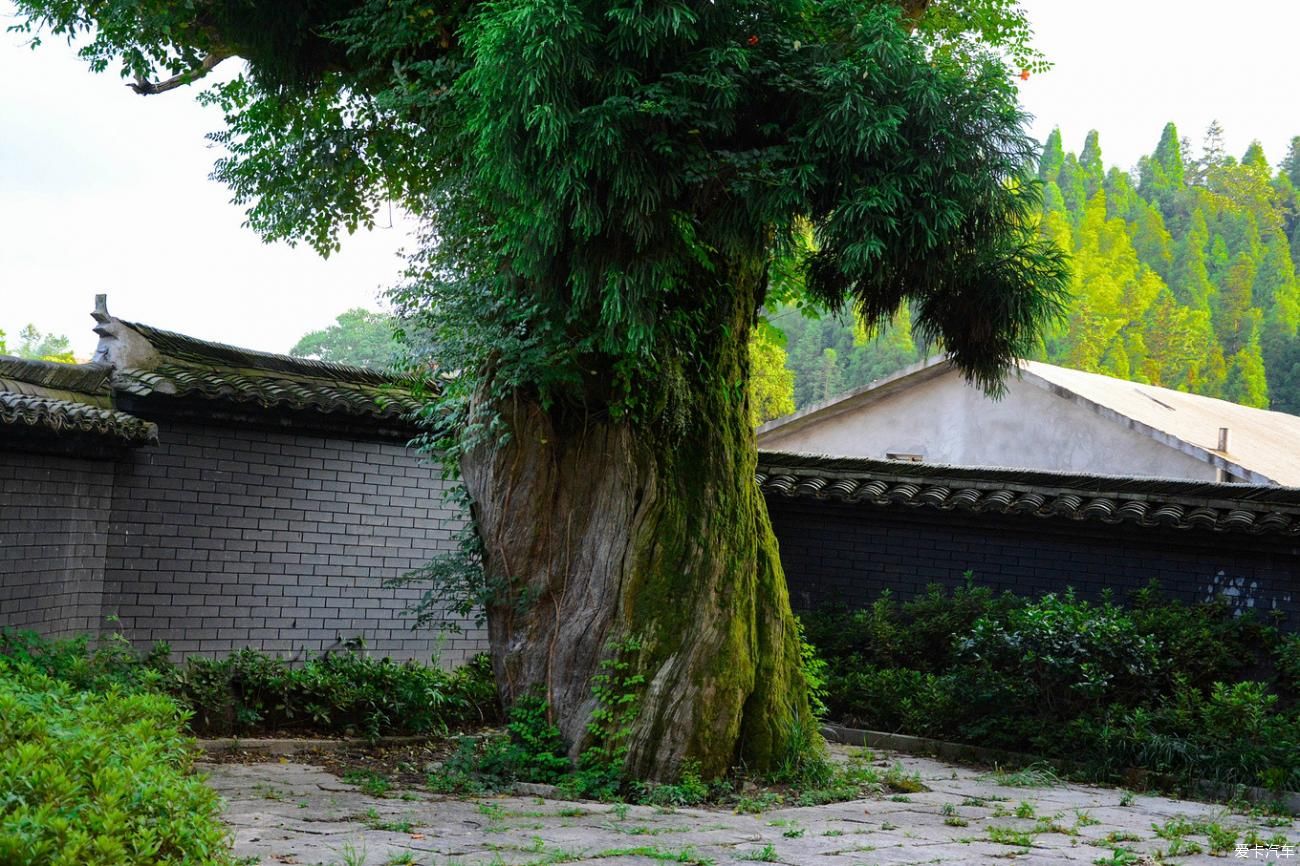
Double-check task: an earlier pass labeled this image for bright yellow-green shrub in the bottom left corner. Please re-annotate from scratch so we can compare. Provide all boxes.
[0,657,230,866]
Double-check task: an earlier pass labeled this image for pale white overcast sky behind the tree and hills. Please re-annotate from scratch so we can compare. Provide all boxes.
[0,0,1300,356]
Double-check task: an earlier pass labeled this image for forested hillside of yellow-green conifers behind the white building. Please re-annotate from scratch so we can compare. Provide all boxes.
[771,124,1300,413]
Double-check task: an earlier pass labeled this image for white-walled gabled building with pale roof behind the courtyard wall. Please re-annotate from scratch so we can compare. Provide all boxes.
[758,359,1300,485]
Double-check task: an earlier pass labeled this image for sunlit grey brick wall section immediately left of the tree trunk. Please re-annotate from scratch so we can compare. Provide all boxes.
[104,420,488,666]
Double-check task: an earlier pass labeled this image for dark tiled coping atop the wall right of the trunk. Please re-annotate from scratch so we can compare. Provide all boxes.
[758,451,1300,536]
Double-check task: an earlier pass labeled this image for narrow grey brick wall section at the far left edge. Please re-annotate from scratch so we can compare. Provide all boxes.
[0,450,113,637]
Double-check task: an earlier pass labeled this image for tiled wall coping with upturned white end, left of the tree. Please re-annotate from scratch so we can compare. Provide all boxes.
[96,305,421,421]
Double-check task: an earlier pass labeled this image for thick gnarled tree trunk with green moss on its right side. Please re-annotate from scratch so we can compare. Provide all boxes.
[463,262,809,780]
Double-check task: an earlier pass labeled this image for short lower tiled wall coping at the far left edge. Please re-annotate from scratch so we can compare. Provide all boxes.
[0,356,157,445]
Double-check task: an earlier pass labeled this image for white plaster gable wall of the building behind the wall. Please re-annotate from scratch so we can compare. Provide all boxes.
[759,373,1216,481]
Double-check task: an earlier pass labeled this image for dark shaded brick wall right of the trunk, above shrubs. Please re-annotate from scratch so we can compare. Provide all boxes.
[768,497,1300,631]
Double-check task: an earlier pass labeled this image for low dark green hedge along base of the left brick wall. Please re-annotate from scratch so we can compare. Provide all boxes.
[0,631,497,737]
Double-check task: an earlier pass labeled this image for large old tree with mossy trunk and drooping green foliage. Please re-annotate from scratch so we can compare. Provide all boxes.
[18,0,1063,779]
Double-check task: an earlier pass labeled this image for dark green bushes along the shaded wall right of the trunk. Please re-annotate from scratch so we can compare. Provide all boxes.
[803,586,1300,789]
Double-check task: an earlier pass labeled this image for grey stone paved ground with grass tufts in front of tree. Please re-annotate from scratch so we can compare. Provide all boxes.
[203,746,1300,866]
